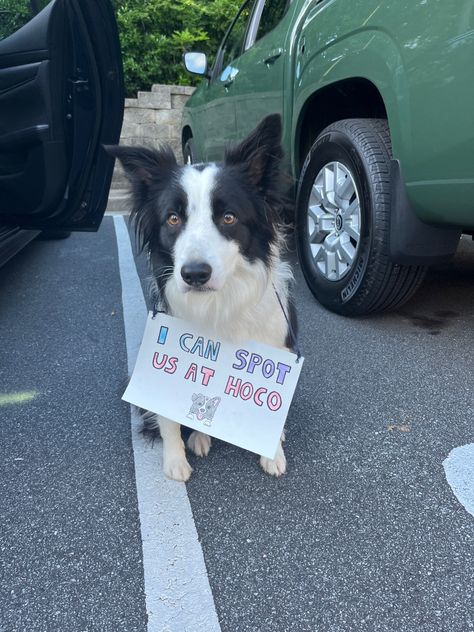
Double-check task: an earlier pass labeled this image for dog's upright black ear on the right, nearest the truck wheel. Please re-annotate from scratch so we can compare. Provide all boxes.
[224,114,283,191]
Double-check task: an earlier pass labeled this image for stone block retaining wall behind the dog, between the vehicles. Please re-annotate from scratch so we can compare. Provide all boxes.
[107,84,194,212]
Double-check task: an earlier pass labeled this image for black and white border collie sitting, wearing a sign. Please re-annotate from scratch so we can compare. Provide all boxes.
[107,115,295,481]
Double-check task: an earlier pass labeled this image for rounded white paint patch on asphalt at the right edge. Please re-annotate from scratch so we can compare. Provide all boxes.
[443,443,474,516]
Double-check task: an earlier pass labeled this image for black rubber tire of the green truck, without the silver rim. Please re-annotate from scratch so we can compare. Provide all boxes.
[296,119,426,316]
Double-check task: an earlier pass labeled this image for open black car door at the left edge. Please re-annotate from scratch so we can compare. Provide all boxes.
[0,0,124,230]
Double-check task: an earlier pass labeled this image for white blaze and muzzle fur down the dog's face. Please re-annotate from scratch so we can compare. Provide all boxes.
[174,164,239,289]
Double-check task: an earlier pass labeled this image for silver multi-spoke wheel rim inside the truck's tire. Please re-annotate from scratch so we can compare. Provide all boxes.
[308,162,361,281]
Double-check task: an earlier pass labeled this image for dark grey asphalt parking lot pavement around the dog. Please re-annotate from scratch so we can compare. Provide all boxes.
[0,217,474,632]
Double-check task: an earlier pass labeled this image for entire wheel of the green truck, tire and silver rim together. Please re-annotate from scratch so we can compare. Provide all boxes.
[296,119,426,316]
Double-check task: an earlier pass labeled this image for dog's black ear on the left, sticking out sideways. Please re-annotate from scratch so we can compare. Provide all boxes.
[104,145,178,186]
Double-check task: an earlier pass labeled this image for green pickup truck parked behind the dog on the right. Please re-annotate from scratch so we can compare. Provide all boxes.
[182,0,474,315]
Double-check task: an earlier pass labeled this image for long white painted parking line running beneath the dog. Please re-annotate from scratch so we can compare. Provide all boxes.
[114,216,220,632]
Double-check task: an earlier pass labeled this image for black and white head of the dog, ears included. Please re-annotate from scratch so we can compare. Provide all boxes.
[106,115,282,293]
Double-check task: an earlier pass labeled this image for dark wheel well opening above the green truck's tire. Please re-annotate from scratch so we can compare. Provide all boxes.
[295,78,387,173]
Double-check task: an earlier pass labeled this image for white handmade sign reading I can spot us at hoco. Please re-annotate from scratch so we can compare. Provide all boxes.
[123,313,303,458]
